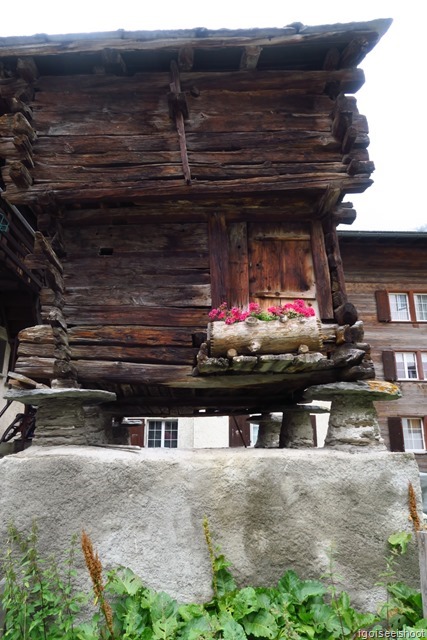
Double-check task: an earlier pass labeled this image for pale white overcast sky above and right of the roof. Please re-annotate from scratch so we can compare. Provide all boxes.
[0,0,427,231]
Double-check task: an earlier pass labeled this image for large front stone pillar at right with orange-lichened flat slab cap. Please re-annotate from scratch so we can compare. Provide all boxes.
[304,380,402,451]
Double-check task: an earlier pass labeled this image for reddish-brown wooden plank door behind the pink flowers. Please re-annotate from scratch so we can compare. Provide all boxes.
[248,222,316,308]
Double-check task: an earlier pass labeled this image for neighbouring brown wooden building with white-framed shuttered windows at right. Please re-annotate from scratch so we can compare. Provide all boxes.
[338,231,427,472]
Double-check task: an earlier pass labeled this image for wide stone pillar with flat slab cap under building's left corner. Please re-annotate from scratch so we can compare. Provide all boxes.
[5,388,116,446]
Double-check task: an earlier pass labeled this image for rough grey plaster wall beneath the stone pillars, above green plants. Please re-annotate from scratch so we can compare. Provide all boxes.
[0,446,420,608]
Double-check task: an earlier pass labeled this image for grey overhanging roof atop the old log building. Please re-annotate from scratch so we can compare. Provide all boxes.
[0,19,392,74]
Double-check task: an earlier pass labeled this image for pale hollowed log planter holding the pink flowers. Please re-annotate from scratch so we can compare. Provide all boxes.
[208,317,323,357]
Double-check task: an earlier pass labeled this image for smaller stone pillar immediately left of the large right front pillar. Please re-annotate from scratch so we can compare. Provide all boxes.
[279,404,328,449]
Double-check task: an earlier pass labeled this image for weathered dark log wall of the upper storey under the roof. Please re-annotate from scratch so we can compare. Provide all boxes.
[0,69,373,204]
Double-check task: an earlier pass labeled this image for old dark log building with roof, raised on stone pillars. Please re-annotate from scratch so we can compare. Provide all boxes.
[0,20,390,424]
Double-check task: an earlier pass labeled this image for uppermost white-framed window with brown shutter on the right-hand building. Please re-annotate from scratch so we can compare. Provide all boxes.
[375,290,427,322]
